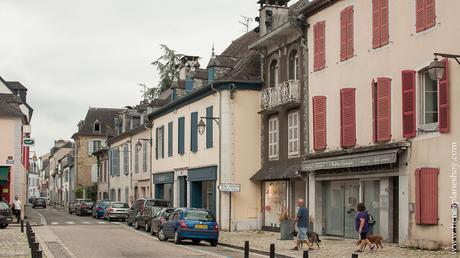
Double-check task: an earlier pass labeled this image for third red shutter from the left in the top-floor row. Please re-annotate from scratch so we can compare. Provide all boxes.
[372,0,389,48]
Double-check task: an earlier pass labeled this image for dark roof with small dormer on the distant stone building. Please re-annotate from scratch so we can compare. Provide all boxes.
[72,107,124,138]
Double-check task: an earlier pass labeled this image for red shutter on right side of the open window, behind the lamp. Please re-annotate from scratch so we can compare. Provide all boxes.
[438,58,449,133]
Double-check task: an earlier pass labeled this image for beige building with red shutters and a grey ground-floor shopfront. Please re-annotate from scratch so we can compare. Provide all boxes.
[303,0,460,245]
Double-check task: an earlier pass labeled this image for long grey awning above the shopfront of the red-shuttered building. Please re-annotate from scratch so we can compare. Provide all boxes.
[302,148,400,171]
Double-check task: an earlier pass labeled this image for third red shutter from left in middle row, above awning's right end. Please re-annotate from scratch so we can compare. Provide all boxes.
[376,78,391,142]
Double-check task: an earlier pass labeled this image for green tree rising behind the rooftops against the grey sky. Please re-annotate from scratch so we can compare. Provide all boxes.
[146,44,182,100]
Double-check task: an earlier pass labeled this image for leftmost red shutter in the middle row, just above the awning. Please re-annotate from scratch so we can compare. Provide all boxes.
[313,96,327,150]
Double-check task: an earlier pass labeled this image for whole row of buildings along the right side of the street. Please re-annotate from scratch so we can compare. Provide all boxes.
[38,0,460,248]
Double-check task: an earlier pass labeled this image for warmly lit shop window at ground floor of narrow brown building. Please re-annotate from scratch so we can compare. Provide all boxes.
[264,181,287,227]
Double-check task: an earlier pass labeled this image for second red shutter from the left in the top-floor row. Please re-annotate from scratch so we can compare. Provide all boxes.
[340,6,354,61]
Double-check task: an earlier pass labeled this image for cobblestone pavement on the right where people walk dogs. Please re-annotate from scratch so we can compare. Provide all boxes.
[219,231,460,258]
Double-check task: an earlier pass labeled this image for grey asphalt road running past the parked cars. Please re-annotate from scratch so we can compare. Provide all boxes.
[29,208,262,258]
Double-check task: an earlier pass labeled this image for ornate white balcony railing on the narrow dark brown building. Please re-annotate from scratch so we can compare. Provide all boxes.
[260,80,300,112]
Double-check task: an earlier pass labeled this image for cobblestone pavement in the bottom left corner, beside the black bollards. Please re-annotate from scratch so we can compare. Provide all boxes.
[0,227,31,258]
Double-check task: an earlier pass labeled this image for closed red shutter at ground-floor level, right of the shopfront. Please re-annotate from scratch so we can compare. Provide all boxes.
[415,168,439,225]
